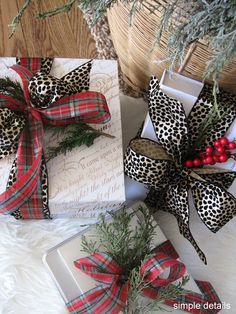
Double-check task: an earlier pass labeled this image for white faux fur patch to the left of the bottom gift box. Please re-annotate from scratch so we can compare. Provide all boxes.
[0,217,87,314]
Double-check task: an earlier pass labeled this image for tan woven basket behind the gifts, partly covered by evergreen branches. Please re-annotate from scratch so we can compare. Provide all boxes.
[107,0,236,93]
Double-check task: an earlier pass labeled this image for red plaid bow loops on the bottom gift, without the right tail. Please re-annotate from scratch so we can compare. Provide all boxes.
[69,248,186,314]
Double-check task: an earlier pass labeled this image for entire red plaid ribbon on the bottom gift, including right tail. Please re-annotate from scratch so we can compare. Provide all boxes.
[67,241,221,314]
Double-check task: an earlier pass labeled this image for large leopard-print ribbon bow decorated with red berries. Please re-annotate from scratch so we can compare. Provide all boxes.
[125,70,236,263]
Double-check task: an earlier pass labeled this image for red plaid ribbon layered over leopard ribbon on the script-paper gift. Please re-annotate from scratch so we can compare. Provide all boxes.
[0,58,110,219]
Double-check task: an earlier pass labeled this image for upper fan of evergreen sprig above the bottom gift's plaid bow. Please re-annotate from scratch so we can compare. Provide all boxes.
[83,207,156,276]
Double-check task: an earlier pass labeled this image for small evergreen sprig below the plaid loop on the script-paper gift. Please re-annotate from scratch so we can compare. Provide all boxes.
[46,123,114,161]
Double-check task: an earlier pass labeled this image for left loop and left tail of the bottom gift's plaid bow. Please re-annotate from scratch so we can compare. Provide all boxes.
[67,252,129,314]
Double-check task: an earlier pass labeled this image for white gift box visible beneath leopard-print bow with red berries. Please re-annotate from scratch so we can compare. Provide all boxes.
[125,70,236,202]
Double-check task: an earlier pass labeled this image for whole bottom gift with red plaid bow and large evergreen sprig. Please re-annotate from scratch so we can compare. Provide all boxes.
[45,203,221,314]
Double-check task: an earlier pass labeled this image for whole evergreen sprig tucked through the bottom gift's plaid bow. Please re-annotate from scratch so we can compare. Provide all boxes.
[82,206,189,314]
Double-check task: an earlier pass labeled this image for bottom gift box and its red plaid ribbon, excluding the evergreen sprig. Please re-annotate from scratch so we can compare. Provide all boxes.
[44,202,221,314]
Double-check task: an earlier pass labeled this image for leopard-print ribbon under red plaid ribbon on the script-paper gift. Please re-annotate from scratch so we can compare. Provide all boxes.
[0,58,96,219]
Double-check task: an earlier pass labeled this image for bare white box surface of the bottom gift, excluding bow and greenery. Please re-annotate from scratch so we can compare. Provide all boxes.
[43,202,205,313]
